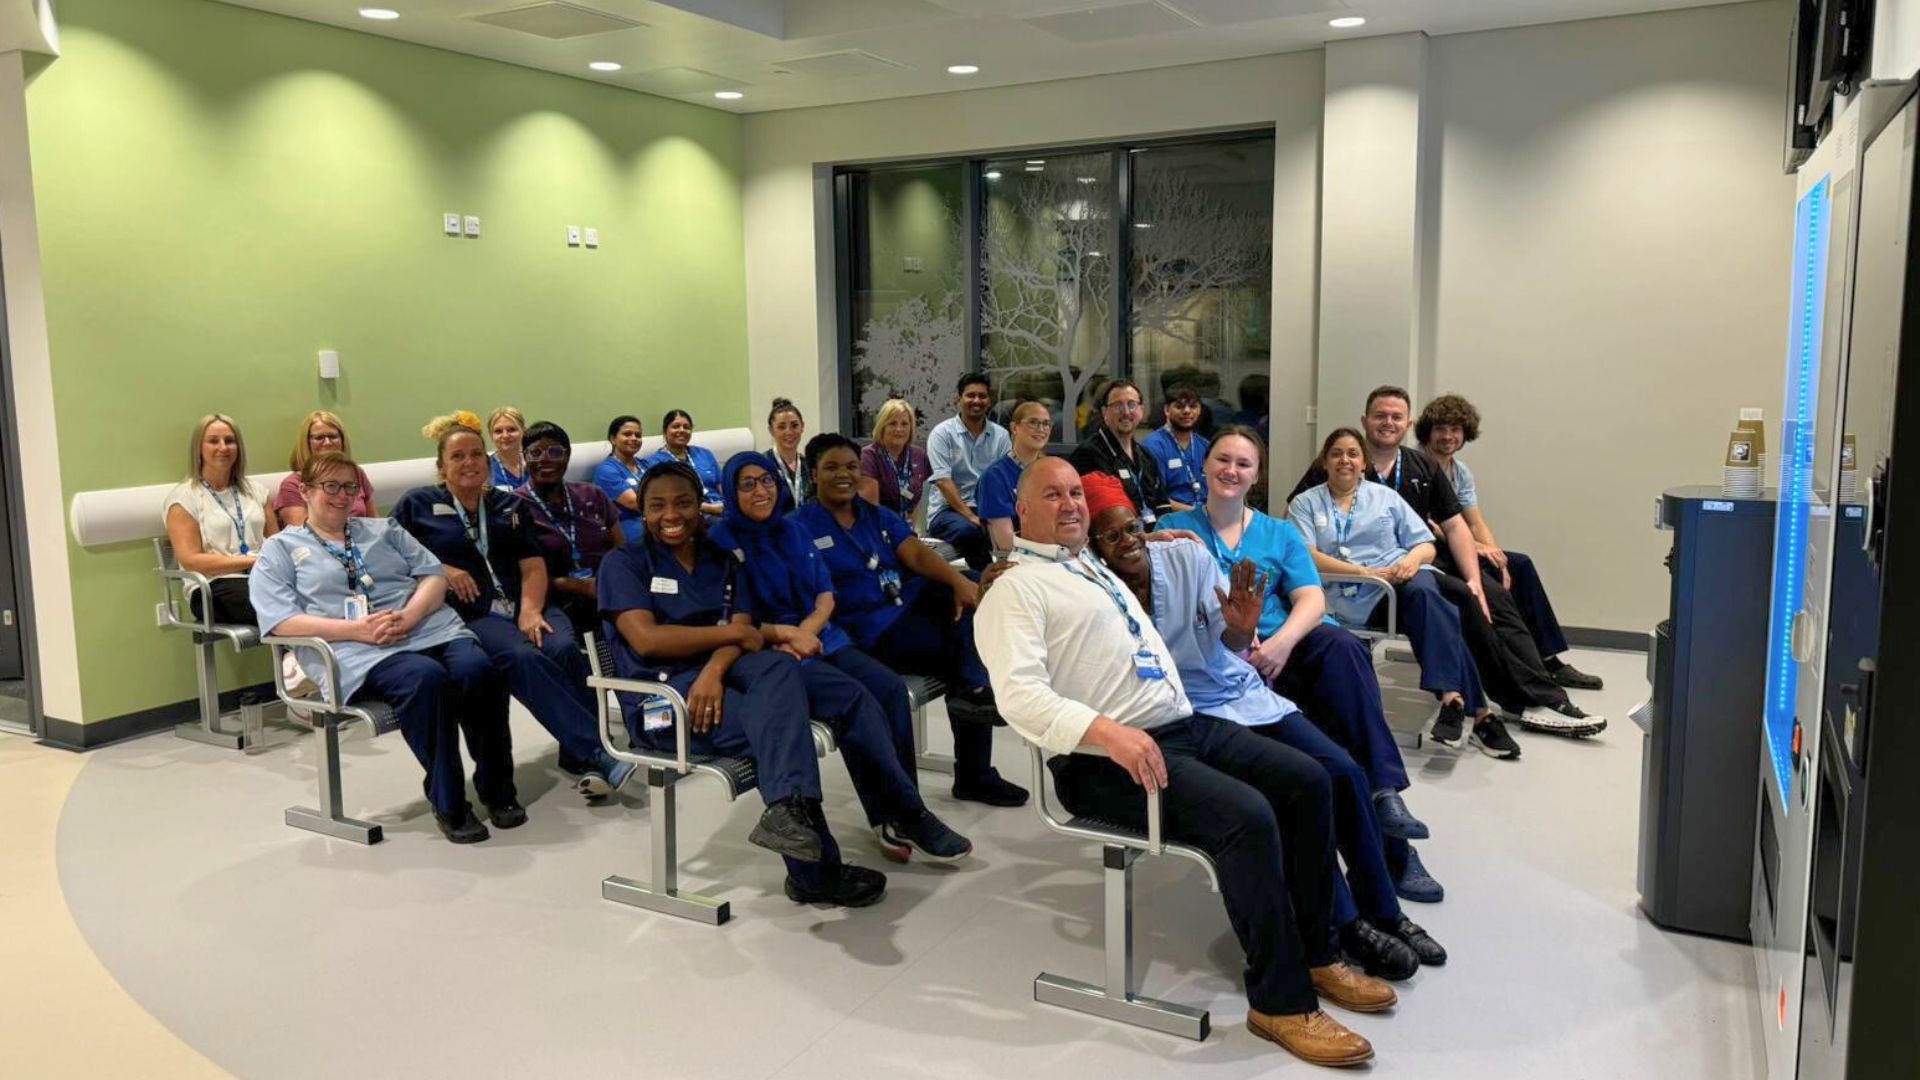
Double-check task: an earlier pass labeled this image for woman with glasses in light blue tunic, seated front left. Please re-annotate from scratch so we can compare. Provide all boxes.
[248,452,510,844]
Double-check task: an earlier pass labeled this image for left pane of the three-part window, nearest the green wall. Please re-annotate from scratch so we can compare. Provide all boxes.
[847,163,968,438]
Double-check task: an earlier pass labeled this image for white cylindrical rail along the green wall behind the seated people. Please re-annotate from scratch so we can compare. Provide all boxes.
[67,427,755,548]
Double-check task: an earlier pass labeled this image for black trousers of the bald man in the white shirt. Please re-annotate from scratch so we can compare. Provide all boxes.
[1050,715,1338,1017]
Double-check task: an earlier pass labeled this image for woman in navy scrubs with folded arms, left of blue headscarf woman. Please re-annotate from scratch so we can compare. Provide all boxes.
[599,461,887,907]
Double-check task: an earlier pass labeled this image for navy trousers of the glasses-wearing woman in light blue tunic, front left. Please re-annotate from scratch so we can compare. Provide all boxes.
[353,638,515,815]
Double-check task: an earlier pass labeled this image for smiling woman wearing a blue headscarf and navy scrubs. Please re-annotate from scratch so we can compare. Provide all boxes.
[708,454,973,863]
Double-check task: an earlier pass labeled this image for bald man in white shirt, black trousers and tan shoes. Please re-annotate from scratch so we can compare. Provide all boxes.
[975,457,1396,1065]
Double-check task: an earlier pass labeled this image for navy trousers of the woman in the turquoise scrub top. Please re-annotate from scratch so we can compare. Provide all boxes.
[1273,623,1407,792]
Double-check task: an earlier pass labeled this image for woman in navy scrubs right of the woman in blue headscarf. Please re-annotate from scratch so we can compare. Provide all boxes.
[793,432,1027,807]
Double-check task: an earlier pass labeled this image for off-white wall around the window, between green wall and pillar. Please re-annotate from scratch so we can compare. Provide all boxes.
[745,52,1323,477]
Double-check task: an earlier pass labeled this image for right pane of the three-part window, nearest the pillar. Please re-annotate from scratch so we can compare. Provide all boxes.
[1127,138,1273,447]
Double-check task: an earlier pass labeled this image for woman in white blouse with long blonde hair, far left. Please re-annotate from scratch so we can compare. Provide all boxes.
[161,413,280,625]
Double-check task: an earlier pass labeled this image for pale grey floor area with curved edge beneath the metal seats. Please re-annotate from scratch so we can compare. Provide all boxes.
[58,651,1757,1080]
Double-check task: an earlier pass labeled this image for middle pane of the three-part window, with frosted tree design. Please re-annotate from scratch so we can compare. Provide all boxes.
[979,152,1117,446]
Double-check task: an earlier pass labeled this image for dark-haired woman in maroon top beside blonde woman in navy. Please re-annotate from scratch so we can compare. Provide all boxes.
[518,421,626,634]
